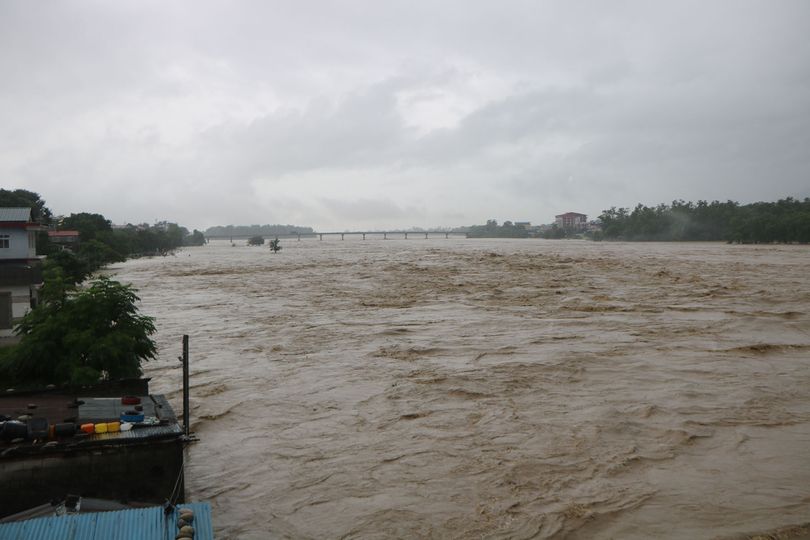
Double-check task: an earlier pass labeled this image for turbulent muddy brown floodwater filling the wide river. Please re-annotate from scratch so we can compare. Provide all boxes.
[115,242,810,539]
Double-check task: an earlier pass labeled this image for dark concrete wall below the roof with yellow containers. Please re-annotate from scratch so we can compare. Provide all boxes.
[0,440,184,517]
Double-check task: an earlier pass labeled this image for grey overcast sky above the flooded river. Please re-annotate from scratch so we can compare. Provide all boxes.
[0,0,810,230]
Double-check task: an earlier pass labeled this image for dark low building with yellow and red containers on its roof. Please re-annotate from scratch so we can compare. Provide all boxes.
[0,379,189,517]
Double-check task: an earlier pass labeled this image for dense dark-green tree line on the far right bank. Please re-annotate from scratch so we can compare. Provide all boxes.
[594,197,810,244]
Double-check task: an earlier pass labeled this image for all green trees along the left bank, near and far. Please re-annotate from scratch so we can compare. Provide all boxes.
[0,189,191,387]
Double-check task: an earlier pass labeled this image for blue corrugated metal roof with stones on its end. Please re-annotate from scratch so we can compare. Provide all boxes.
[0,503,214,540]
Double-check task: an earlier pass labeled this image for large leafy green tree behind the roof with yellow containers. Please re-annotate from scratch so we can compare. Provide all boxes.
[3,276,157,385]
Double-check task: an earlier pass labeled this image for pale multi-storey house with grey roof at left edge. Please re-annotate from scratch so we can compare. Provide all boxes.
[0,208,43,339]
